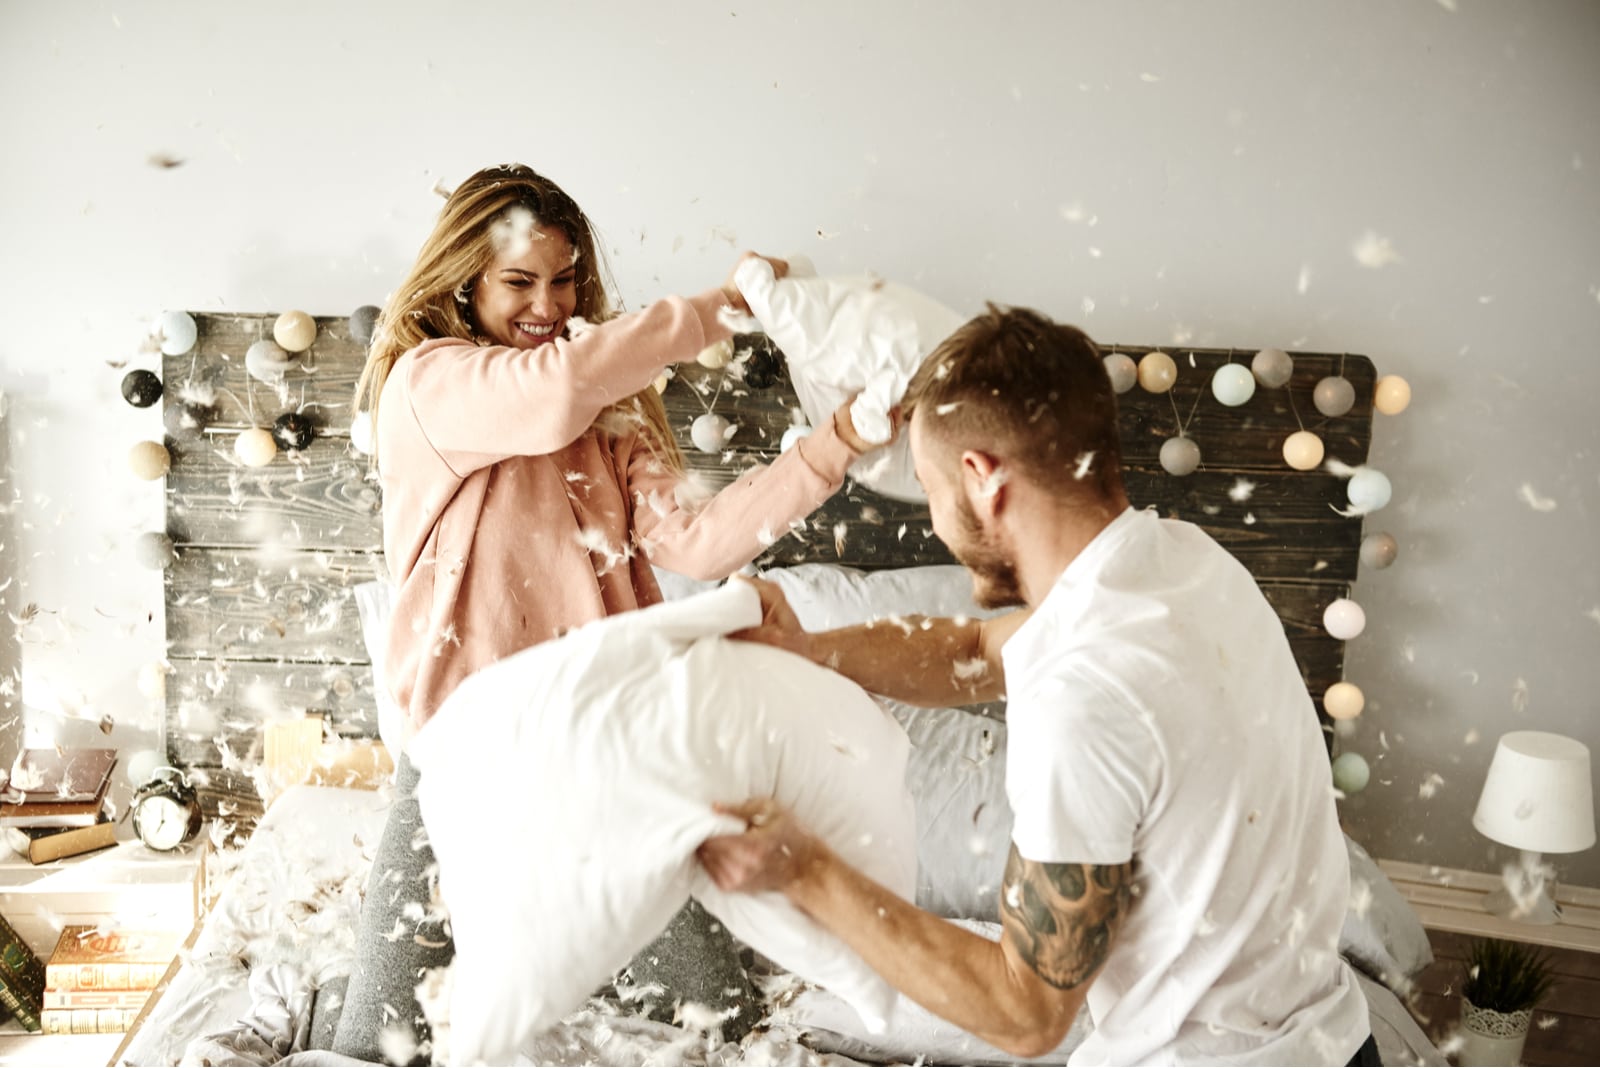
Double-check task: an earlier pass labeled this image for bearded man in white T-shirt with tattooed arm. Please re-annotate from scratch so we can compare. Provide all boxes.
[701,305,1378,1065]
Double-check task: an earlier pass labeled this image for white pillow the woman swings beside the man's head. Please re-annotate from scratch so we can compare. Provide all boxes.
[734,256,963,500]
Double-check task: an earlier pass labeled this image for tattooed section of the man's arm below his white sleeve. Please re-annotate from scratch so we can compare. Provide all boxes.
[1000,846,1133,990]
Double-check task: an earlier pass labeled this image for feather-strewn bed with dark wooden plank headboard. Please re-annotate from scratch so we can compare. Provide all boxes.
[117,303,1446,1065]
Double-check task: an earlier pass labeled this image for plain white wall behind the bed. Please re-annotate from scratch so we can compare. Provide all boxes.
[0,0,1600,886]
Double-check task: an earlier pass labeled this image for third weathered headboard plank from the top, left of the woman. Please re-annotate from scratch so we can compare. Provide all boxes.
[166,547,378,664]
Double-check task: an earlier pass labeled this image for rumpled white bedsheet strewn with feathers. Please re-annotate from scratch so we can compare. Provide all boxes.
[118,787,1448,1065]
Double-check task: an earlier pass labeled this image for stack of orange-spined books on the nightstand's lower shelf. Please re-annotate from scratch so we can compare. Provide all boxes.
[40,924,182,1034]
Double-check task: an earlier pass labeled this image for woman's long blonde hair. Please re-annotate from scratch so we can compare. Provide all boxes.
[355,163,683,472]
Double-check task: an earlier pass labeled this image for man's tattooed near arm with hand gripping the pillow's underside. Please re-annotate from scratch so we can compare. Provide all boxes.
[699,801,1133,1057]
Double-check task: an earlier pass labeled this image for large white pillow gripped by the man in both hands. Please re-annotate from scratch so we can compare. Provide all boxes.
[410,582,917,1063]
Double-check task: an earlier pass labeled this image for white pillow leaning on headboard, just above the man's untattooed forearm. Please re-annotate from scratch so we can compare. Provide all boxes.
[760,564,995,630]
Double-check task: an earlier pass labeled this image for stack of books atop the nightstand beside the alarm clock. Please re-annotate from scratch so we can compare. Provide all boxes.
[0,748,117,863]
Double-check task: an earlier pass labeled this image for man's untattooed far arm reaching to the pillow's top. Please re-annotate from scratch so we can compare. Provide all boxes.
[733,579,1032,708]
